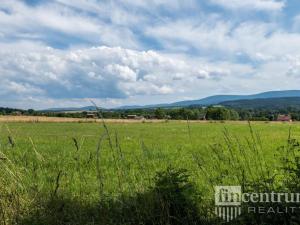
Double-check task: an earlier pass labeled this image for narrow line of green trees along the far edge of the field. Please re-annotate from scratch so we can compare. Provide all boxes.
[0,106,300,121]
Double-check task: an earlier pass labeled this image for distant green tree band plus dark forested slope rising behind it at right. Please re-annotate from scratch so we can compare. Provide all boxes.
[0,97,300,121]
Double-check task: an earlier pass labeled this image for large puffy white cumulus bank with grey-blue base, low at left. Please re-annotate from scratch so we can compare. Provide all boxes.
[0,46,228,104]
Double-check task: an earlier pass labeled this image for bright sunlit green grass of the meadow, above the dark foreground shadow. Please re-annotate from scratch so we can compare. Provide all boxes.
[0,122,300,224]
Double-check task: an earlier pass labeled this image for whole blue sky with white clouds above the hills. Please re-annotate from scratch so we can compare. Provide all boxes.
[0,0,300,109]
